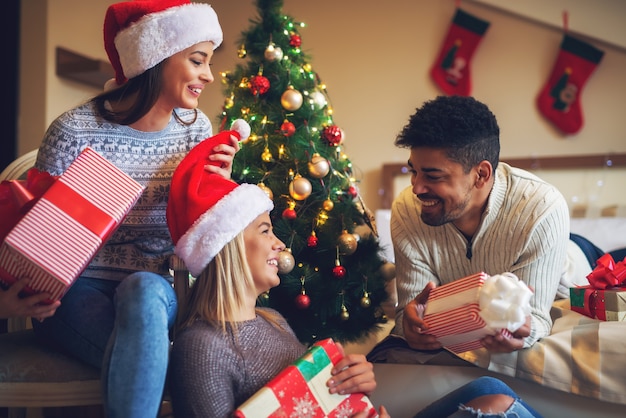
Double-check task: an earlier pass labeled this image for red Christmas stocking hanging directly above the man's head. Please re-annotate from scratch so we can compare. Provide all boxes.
[430,9,489,96]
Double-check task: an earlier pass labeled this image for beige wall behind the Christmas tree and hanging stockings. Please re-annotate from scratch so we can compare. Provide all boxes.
[19,0,626,210]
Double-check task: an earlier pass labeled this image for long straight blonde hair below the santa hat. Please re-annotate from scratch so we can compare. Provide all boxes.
[176,231,284,333]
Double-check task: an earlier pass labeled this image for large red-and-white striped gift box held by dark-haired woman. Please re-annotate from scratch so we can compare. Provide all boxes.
[0,148,144,300]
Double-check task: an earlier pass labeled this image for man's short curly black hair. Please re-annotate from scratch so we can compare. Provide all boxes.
[395,96,500,173]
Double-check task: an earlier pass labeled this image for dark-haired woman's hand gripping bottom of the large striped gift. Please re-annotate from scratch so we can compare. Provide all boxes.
[0,278,61,321]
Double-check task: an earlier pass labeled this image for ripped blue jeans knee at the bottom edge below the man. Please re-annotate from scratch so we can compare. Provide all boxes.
[414,376,541,418]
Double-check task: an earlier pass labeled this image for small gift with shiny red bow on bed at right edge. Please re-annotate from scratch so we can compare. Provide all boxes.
[570,254,626,321]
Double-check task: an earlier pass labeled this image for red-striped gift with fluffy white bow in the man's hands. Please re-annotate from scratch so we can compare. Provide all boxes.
[424,272,533,353]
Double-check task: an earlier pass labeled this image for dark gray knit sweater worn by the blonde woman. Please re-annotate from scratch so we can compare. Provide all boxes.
[169,308,306,418]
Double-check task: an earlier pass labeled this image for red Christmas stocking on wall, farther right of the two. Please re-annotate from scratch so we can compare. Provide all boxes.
[537,35,604,134]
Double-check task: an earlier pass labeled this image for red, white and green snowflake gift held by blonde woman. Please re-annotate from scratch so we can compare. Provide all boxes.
[234,338,378,418]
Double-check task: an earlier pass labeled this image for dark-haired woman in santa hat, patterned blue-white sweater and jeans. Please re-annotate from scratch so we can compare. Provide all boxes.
[28,0,238,418]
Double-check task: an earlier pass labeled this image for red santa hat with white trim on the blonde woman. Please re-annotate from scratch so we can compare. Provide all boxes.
[166,119,274,277]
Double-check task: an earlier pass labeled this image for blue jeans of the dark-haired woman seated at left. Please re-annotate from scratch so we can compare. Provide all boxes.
[33,272,178,418]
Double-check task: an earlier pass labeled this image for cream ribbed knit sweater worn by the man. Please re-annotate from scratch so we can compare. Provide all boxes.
[391,163,569,347]
